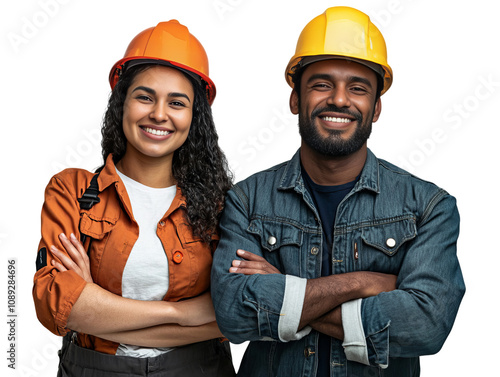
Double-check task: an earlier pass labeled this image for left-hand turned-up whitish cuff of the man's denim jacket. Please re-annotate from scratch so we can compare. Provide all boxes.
[278,275,311,342]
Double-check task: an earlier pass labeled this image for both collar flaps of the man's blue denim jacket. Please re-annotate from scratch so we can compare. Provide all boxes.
[279,148,380,193]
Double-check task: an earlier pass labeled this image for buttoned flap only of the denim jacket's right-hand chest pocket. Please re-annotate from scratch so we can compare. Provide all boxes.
[361,215,417,256]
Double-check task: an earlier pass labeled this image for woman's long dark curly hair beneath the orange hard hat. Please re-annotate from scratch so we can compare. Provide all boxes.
[101,64,232,243]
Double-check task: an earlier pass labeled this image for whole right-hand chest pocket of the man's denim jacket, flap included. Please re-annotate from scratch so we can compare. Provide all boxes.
[354,216,417,273]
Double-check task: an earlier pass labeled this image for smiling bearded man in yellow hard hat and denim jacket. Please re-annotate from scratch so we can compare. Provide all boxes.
[212,7,465,377]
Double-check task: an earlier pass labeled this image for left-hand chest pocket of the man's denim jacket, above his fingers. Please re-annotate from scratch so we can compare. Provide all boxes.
[247,218,304,276]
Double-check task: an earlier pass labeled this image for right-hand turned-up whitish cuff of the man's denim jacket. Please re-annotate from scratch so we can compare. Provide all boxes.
[342,299,370,365]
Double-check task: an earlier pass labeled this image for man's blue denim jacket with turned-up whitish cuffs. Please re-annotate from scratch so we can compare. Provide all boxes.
[211,150,465,377]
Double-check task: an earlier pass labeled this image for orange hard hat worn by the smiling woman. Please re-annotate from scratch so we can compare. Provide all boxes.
[109,20,215,105]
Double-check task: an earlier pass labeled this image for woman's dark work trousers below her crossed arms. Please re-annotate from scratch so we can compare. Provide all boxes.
[57,336,235,377]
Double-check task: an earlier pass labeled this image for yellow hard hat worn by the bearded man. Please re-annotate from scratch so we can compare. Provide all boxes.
[285,7,392,94]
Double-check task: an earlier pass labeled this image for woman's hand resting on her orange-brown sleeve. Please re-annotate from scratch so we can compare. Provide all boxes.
[50,233,93,283]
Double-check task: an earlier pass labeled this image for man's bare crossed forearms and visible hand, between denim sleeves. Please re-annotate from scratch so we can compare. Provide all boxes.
[229,250,397,340]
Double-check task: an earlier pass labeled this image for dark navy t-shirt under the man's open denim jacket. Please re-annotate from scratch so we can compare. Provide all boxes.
[302,167,359,377]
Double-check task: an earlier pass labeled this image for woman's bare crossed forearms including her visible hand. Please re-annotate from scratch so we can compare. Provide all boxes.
[50,234,222,347]
